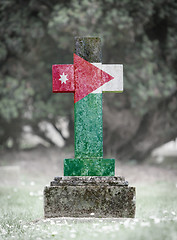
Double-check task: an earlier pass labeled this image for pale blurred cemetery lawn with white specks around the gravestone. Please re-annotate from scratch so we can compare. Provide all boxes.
[0,147,177,240]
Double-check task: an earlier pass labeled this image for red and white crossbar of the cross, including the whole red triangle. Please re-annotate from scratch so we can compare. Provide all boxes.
[52,54,123,103]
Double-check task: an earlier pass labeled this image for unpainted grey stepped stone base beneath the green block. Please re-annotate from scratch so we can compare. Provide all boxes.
[44,177,135,218]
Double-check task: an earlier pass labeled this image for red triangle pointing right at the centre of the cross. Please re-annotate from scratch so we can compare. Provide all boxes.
[74,54,113,102]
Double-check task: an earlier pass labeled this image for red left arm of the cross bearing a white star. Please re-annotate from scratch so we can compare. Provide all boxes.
[52,64,74,93]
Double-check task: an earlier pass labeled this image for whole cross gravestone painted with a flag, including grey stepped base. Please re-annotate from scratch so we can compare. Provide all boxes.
[44,37,135,218]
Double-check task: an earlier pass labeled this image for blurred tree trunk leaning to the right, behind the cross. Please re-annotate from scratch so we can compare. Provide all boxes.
[105,90,177,162]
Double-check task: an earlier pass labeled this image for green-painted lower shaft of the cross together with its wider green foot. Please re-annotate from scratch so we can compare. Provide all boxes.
[64,93,115,176]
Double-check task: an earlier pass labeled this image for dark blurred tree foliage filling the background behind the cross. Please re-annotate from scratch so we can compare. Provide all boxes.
[0,0,177,160]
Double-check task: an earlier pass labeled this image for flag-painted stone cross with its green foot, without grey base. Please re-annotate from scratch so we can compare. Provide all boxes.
[52,37,123,176]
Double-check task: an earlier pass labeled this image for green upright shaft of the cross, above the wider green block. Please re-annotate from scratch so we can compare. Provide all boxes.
[74,93,103,158]
